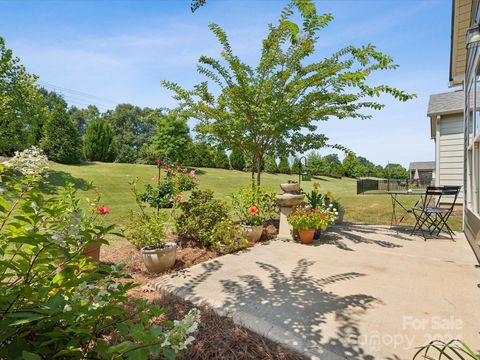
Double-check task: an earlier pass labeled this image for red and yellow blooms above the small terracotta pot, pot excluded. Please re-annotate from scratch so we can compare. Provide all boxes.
[287,206,335,230]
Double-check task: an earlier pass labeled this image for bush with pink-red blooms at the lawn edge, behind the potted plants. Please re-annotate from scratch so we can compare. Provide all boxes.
[140,160,197,209]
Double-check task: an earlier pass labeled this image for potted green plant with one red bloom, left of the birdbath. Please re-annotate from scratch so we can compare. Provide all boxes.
[231,186,277,243]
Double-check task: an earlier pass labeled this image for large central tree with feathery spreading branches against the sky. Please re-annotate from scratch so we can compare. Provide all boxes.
[162,0,413,183]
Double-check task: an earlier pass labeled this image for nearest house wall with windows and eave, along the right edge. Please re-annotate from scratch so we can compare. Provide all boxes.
[449,0,480,259]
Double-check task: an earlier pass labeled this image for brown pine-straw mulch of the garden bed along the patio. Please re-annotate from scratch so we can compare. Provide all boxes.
[102,221,304,360]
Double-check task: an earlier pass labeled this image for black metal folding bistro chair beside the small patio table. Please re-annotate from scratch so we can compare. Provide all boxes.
[412,186,461,241]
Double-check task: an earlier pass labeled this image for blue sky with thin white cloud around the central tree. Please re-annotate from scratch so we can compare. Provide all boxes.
[0,0,451,166]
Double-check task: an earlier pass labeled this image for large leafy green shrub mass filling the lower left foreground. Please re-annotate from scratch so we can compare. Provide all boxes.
[0,169,198,359]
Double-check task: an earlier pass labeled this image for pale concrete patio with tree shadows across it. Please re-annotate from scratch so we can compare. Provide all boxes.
[154,225,480,359]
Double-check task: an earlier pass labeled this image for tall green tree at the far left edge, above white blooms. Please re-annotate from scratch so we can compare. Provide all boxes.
[0,37,47,156]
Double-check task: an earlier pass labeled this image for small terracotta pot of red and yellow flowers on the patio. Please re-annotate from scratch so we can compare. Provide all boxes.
[287,206,331,244]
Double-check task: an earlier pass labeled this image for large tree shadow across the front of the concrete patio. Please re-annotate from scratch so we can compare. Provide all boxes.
[221,259,381,360]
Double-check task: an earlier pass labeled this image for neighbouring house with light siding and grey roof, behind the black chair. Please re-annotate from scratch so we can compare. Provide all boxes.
[427,90,465,205]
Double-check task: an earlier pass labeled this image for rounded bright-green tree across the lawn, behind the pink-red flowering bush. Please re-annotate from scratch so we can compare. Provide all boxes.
[152,111,192,164]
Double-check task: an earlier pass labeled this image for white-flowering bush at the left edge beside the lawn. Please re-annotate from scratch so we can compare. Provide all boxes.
[3,146,50,176]
